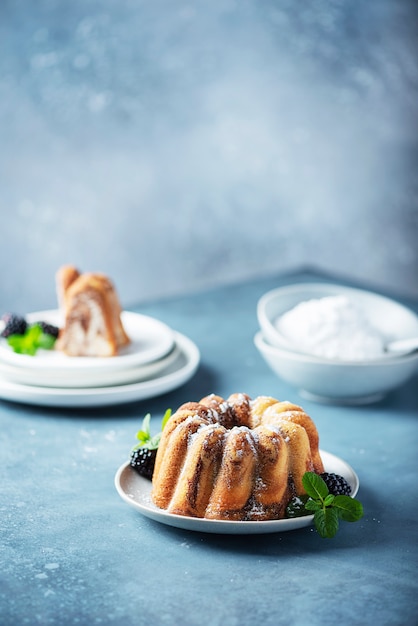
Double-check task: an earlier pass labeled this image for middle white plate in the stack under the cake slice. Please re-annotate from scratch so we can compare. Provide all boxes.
[0,344,180,389]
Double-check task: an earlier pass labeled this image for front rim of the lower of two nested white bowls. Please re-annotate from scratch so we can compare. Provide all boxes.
[254,330,418,369]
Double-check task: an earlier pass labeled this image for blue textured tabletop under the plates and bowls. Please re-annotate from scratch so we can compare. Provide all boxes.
[0,271,418,626]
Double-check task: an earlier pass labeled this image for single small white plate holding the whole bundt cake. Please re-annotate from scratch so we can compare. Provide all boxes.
[115,450,360,535]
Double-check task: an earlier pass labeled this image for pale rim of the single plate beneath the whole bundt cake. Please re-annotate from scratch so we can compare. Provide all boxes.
[114,449,360,535]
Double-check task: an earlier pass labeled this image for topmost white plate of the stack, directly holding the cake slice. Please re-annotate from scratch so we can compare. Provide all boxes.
[0,310,174,376]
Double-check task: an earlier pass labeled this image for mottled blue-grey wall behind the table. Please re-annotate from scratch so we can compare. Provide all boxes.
[0,0,418,313]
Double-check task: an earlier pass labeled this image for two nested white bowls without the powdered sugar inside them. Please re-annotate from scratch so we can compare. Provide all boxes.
[254,283,418,404]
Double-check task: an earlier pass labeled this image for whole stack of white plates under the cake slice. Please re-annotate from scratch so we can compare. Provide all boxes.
[0,310,200,407]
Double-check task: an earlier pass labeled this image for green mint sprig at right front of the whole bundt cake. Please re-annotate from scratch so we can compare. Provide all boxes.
[302,472,363,539]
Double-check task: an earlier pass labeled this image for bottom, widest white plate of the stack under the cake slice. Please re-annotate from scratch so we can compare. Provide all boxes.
[0,332,200,408]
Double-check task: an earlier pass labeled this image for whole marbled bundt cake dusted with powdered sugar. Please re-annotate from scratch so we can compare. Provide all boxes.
[152,393,324,521]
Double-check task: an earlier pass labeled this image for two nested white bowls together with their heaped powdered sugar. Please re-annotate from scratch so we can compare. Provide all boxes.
[254,283,418,403]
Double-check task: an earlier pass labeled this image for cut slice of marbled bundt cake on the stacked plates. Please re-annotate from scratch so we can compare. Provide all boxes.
[56,266,130,357]
